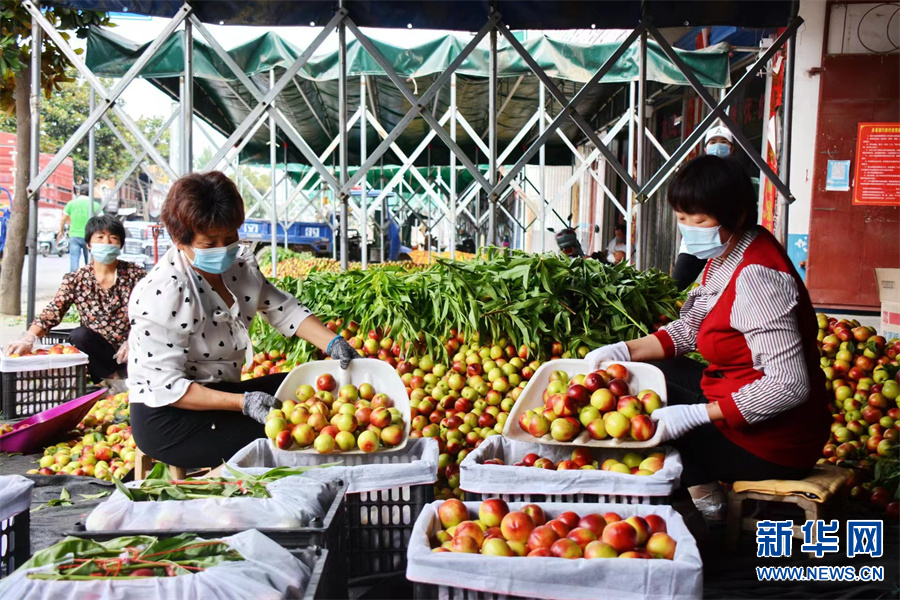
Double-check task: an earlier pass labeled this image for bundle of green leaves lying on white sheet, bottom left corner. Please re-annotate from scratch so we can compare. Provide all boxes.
[23,534,244,581]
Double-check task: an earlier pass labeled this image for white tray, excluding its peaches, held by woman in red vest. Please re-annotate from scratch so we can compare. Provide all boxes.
[503,358,668,448]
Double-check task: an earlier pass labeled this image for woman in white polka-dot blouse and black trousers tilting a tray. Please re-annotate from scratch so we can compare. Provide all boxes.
[128,171,358,467]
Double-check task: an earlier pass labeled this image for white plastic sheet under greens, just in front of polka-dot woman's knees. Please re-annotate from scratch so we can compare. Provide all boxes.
[85,476,333,531]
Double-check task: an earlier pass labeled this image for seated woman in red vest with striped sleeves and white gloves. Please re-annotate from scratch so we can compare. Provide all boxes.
[587,156,831,494]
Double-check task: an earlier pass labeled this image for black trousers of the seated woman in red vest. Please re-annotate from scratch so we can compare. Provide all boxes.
[651,357,810,487]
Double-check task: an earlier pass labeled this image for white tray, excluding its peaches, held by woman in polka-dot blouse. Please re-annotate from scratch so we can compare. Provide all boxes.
[269,358,412,456]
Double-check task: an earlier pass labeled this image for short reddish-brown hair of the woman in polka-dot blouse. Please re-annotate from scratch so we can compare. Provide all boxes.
[160,171,244,244]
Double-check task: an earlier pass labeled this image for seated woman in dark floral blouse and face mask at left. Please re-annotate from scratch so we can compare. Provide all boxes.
[7,215,146,390]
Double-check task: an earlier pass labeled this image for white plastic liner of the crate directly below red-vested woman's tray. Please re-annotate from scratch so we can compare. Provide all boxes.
[459,435,683,496]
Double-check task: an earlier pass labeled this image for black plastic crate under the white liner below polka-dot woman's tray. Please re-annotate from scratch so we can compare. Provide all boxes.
[346,483,434,584]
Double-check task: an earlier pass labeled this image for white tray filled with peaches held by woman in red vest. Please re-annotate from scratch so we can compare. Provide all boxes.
[503,359,666,448]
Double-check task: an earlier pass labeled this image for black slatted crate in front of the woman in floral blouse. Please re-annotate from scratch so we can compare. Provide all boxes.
[0,365,87,420]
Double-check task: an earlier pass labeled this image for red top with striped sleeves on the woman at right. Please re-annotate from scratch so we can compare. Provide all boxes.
[655,227,831,467]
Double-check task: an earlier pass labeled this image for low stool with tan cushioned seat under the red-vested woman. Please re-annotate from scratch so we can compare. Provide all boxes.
[727,464,850,549]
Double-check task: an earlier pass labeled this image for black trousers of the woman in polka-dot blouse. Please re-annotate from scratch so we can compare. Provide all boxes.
[131,373,287,468]
